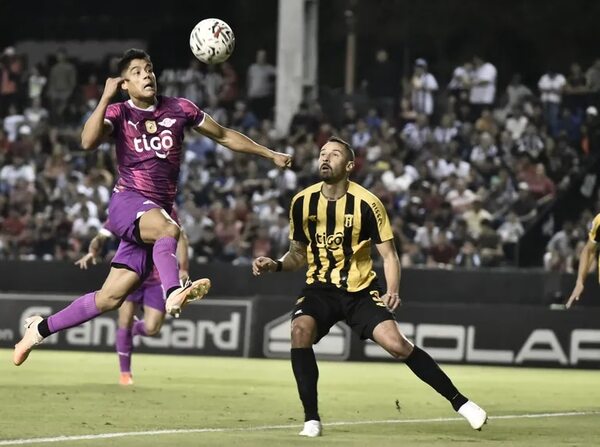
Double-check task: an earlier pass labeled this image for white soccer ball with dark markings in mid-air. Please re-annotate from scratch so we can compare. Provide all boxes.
[190,19,235,64]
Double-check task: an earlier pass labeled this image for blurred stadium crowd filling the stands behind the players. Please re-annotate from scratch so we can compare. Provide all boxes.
[0,47,600,270]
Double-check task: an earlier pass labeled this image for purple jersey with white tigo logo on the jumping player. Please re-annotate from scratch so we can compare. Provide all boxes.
[104,96,204,210]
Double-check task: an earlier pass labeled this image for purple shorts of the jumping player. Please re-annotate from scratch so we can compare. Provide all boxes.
[106,191,161,281]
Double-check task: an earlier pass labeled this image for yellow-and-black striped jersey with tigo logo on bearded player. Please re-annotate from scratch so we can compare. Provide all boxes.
[290,182,393,292]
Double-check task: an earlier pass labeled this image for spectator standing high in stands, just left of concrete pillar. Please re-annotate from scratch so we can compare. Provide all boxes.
[247,49,277,119]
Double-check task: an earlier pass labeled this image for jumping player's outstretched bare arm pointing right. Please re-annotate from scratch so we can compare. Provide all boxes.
[195,115,292,168]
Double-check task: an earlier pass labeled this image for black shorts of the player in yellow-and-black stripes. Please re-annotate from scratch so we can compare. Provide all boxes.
[292,280,396,343]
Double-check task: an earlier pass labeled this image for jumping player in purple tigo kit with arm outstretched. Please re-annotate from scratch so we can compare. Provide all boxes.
[13,49,291,366]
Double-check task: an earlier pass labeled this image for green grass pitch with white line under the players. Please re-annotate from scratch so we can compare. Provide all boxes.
[0,349,600,447]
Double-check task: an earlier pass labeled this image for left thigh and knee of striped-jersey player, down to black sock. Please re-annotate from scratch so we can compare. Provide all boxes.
[292,288,343,348]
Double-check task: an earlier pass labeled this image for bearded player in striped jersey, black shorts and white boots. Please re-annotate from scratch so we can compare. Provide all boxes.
[252,137,487,437]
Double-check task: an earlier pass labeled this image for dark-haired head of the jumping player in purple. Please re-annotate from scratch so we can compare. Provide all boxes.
[117,48,156,101]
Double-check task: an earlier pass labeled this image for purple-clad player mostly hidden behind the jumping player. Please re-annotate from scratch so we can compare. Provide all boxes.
[75,209,189,385]
